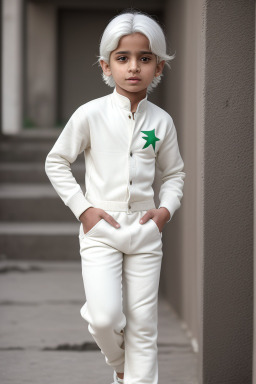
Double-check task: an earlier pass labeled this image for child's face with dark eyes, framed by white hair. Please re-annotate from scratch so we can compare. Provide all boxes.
[101,32,164,97]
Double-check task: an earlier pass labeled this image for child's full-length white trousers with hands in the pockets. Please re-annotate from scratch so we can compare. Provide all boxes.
[79,210,163,384]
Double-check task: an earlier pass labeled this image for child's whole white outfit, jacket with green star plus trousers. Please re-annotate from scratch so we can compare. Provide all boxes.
[45,89,185,384]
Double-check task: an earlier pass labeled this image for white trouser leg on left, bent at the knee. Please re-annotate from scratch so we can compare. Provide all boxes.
[80,234,126,372]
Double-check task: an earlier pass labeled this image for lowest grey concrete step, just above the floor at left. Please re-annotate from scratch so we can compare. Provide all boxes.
[0,221,80,260]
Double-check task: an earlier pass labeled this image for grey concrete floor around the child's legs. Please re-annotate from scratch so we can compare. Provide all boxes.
[0,260,198,384]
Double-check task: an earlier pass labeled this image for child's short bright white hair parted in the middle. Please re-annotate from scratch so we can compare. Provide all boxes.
[98,11,175,93]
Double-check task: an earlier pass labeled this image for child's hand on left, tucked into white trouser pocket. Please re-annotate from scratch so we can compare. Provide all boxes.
[79,207,120,233]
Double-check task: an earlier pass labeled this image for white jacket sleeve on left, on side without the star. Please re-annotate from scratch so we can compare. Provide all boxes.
[45,106,93,221]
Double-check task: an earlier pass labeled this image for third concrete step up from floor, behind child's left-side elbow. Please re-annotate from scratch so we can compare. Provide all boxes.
[0,163,85,184]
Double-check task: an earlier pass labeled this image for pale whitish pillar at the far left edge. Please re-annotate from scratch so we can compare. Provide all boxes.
[2,0,23,134]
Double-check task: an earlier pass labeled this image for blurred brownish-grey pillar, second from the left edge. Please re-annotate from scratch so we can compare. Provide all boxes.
[26,2,58,127]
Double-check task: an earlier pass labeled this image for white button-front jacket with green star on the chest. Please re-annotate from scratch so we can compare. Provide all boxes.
[45,88,186,222]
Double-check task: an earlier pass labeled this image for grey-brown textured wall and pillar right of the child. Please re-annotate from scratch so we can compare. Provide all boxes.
[163,0,255,384]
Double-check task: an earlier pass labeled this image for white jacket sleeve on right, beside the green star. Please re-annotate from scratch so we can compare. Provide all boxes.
[156,118,186,223]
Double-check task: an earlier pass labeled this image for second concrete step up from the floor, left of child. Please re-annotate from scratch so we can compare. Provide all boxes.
[0,182,85,223]
